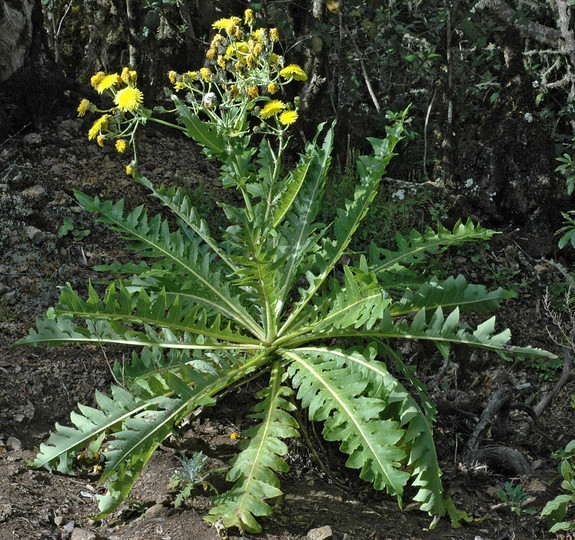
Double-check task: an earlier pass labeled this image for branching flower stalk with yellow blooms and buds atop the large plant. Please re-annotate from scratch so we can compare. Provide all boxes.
[78,9,307,185]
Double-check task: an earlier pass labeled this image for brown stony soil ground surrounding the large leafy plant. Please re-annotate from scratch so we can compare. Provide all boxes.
[0,110,575,540]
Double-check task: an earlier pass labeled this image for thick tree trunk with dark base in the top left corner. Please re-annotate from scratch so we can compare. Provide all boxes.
[0,0,67,141]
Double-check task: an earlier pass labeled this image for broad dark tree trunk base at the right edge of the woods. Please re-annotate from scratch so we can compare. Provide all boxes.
[462,27,559,256]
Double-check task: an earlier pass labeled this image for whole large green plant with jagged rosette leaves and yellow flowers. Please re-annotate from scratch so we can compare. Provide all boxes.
[19,10,551,532]
